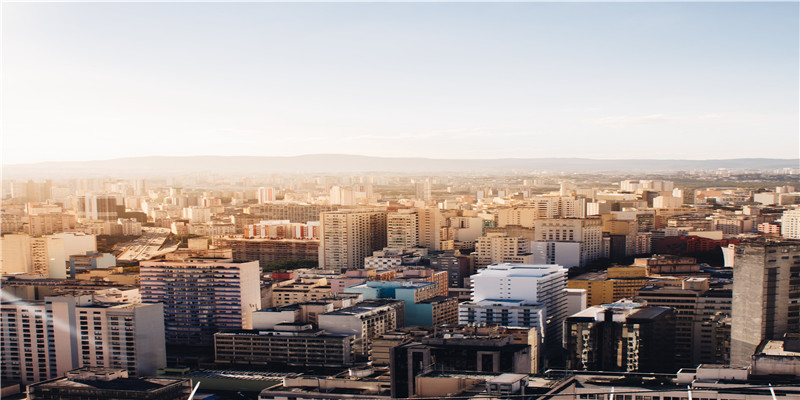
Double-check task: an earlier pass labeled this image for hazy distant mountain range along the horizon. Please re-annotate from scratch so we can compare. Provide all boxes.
[3,154,800,179]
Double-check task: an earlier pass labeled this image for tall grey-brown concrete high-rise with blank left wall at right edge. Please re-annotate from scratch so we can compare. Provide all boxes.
[731,240,800,364]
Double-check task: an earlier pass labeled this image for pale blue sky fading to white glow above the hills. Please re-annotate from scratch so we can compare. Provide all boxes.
[2,2,800,164]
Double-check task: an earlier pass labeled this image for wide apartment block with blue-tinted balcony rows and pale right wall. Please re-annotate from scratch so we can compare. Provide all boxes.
[139,257,261,346]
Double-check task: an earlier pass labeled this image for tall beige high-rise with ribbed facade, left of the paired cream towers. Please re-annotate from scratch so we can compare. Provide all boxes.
[319,210,386,271]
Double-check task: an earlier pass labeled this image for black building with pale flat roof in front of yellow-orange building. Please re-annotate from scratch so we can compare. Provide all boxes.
[564,302,675,372]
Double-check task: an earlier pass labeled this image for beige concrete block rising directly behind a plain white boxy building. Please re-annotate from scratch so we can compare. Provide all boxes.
[534,218,603,266]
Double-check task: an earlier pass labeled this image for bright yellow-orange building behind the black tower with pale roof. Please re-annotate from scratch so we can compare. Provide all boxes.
[567,266,650,306]
